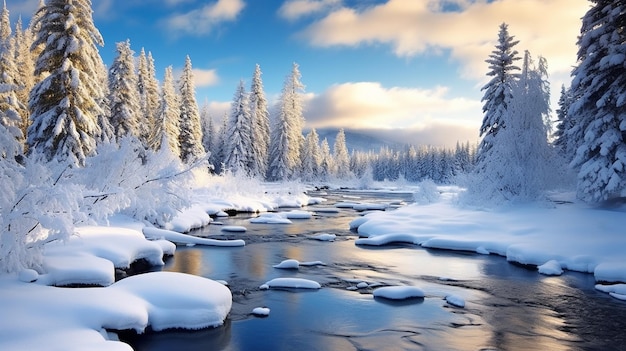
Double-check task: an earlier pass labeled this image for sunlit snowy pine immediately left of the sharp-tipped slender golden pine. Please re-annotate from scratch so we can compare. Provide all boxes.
[150,66,180,157]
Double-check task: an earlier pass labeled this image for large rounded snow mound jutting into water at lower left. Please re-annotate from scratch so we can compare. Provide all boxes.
[109,272,232,331]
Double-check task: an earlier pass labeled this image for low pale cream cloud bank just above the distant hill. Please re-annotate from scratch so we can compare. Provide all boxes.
[305,82,482,146]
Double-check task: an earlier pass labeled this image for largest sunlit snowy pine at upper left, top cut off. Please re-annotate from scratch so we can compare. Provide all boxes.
[27,0,105,165]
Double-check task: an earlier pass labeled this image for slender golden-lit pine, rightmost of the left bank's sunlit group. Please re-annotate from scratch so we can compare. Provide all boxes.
[178,56,206,164]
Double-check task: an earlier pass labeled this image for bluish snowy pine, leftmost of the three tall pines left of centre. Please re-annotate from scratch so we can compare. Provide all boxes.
[224,80,254,175]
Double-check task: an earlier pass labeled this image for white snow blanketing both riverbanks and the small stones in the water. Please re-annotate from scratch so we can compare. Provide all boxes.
[0,180,626,350]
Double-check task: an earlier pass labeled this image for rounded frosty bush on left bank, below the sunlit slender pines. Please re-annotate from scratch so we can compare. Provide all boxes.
[77,138,196,226]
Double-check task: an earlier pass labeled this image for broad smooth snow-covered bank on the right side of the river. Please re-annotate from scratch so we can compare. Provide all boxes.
[351,187,626,292]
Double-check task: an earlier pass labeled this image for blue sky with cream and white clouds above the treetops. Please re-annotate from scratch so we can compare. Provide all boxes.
[6,0,590,145]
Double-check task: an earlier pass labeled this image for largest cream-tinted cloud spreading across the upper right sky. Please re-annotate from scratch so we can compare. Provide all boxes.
[300,0,589,79]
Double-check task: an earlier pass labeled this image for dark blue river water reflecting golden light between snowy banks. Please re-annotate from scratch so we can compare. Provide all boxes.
[120,192,626,351]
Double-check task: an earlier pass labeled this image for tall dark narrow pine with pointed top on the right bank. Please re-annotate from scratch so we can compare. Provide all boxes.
[479,23,520,163]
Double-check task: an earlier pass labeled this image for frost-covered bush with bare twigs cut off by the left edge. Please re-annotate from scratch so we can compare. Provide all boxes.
[0,145,89,272]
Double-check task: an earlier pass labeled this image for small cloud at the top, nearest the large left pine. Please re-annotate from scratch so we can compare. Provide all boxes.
[165,0,245,35]
